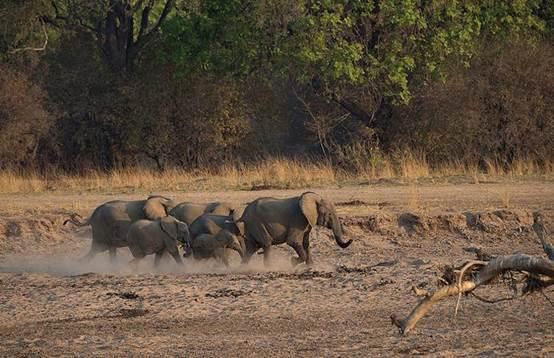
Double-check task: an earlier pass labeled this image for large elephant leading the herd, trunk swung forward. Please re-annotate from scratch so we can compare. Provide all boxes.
[235,192,352,265]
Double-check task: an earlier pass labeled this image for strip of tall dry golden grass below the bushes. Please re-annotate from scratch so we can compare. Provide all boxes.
[0,154,554,194]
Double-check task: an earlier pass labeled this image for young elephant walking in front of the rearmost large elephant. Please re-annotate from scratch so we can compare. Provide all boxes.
[127,216,190,266]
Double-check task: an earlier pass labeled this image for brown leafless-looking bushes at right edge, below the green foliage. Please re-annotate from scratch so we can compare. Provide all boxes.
[385,43,554,164]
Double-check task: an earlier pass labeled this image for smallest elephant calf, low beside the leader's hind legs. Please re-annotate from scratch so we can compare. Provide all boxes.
[191,230,244,267]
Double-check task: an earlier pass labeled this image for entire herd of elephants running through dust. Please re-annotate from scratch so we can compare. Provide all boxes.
[64,192,352,266]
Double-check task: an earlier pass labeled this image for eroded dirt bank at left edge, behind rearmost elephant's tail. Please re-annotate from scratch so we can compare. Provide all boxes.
[0,211,82,257]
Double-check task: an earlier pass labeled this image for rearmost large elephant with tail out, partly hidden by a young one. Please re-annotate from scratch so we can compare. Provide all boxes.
[64,195,177,262]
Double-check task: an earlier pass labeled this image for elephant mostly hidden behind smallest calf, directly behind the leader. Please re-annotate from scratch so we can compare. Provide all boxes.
[185,211,245,257]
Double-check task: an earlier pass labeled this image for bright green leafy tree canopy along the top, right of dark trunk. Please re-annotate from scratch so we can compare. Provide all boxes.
[165,0,544,103]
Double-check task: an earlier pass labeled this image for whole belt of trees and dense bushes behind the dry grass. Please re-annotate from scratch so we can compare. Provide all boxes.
[0,0,554,172]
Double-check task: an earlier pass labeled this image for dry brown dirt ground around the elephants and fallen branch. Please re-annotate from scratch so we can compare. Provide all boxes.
[0,182,554,357]
